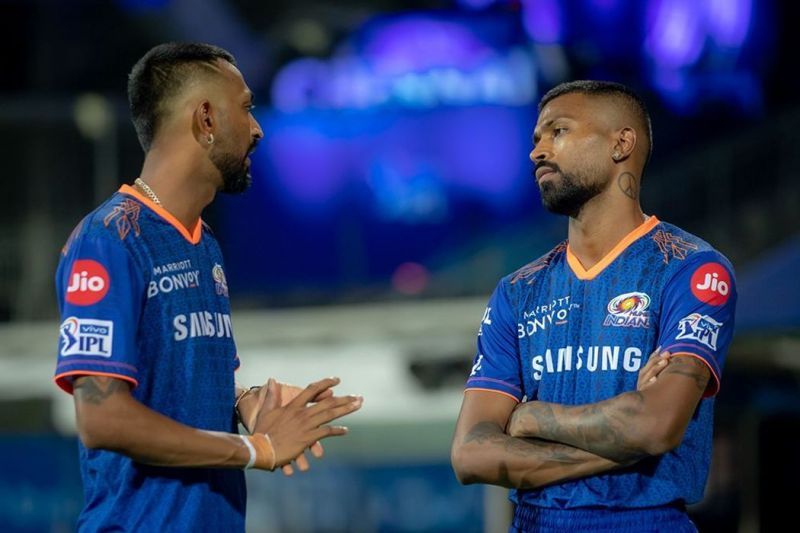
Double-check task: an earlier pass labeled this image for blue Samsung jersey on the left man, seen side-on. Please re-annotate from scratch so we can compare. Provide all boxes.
[55,186,246,531]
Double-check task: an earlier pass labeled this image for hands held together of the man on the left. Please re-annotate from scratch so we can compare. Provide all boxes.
[245,378,363,475]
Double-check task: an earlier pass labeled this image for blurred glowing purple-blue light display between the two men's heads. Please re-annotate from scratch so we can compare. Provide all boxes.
[272,16,536,113]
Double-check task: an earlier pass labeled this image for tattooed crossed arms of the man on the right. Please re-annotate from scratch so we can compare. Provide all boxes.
[451,352,710,489]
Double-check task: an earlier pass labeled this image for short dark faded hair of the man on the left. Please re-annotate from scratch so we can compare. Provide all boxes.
[128,43,236,152]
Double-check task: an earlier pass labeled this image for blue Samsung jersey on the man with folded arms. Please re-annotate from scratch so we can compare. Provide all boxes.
[467,217,736,508]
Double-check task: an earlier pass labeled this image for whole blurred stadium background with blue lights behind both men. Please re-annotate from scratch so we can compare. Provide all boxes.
[0,0,800,532]
